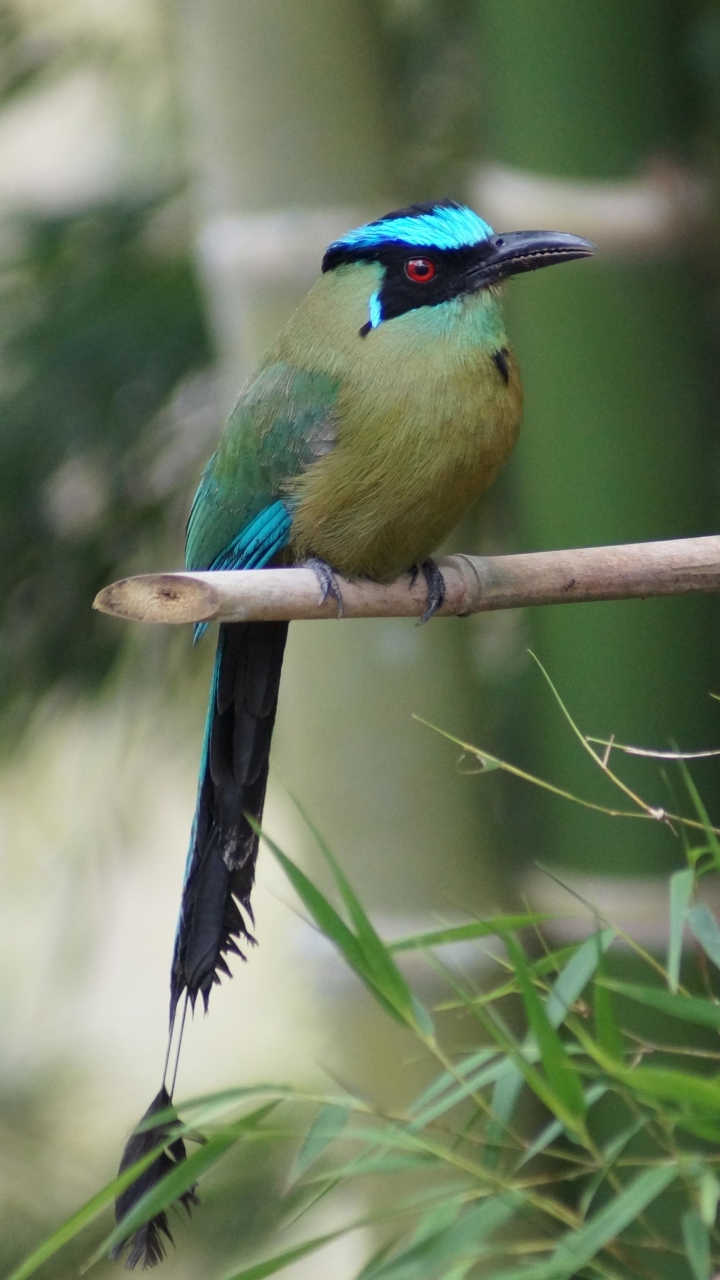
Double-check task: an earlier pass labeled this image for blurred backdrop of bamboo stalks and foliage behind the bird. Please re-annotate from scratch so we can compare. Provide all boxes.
[0,0,720,1280]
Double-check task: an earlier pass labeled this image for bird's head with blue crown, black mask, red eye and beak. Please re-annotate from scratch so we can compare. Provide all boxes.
[323,200,596,337]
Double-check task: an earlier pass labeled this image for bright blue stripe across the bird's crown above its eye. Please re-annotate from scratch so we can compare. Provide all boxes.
[328,205,493,252]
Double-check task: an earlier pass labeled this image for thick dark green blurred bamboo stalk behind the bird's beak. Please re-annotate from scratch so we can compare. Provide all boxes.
[477,0,719,877]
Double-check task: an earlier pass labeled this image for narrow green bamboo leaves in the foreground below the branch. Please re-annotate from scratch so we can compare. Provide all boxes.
[9,708,720,1280]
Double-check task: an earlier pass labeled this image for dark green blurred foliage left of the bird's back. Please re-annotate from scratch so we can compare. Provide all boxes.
[0,200,209,705]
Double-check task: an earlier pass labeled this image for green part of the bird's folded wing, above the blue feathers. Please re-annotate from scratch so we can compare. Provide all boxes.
[186,362,340,570]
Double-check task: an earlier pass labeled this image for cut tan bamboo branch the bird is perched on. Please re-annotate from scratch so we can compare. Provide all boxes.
[94,535,720,622]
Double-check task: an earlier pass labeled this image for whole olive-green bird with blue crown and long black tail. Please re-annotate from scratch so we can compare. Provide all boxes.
[114,200,596,1268]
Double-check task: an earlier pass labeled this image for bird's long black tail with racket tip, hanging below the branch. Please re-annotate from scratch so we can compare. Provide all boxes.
[113,622,288,1268]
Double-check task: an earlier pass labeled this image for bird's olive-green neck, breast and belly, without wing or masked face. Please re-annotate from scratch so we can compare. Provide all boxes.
[268,265,523,581]
